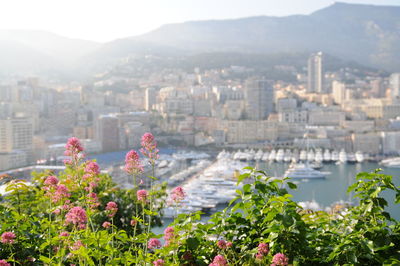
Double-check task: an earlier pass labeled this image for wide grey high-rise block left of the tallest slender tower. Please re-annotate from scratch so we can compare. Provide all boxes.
[245,79,275,120]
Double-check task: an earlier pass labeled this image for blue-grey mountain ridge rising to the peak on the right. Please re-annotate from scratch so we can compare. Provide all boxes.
[91,3,400,71]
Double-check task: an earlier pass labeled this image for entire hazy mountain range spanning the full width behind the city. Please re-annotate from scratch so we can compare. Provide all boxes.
[0,3,400,78]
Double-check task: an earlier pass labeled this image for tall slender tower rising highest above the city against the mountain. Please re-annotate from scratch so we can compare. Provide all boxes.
[307,52,325,93]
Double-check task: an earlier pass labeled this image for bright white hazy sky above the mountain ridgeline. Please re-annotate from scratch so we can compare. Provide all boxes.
[0,0,400,41]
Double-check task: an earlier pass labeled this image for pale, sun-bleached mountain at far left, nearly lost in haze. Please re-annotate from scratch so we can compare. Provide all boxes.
[0,30,101,78]
